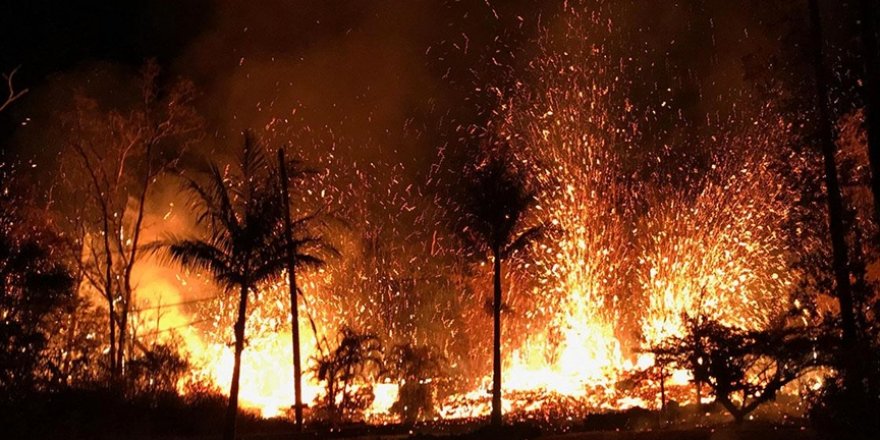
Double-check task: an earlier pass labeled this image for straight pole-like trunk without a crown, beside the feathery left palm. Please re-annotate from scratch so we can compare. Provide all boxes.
[278,148,303,432]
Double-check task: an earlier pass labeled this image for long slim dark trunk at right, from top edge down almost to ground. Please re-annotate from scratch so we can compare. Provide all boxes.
[809,0,856,376]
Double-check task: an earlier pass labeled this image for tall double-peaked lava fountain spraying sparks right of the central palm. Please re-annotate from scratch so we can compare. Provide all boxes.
[424,6,797,417]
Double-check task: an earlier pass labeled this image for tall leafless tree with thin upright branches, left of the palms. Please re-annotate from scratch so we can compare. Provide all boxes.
[65,61,200,382]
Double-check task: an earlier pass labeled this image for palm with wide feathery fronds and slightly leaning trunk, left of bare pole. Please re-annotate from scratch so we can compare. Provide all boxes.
[166,134,286,440]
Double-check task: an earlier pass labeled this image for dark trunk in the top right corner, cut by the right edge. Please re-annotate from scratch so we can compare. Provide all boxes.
[859,0,880,224]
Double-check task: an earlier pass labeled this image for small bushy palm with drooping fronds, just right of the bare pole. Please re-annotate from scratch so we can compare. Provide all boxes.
[312,327,382,423]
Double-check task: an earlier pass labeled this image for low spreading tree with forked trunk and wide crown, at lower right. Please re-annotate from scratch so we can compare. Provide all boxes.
[653,316,820,423]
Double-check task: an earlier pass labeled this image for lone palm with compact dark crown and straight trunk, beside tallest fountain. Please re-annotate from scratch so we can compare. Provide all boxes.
[460,144,544,426]
